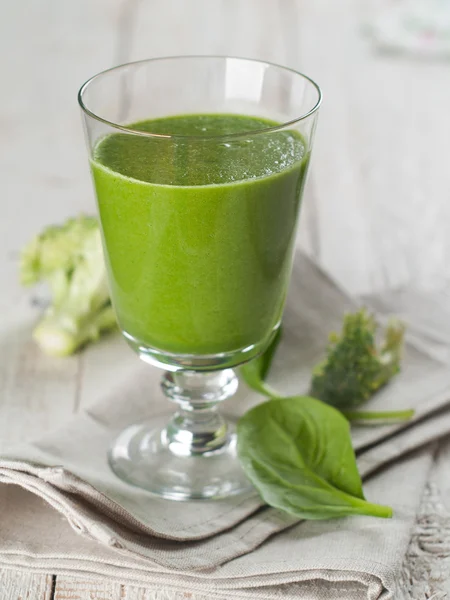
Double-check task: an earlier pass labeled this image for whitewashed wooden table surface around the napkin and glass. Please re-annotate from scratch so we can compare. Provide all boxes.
[0,0,450,600]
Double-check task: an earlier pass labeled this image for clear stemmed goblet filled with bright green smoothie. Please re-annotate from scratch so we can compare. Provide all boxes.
[79,56,321,500]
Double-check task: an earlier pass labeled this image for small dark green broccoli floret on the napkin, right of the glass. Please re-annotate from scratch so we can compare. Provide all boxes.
[310,309,405,410]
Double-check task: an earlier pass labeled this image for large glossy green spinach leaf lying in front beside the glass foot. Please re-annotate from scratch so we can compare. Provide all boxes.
[237,396,392,519]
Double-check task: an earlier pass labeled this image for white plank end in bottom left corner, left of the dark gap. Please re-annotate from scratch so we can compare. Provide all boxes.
[0,569,53,600]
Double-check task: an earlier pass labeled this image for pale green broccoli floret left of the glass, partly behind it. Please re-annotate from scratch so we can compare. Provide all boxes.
[20,216,116,356]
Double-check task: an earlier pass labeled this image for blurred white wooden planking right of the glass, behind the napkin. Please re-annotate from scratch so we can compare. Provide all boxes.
[298,2,450,291]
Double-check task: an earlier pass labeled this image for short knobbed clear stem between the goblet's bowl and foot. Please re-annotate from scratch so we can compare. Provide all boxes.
[161,369,238,456]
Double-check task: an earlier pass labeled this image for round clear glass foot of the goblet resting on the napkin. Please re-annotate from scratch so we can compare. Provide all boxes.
[109,417,253,500]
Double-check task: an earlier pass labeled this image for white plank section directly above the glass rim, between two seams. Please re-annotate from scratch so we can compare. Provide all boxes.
[130,0,291,62]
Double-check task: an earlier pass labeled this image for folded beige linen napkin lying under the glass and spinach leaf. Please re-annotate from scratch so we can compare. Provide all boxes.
[0,255,450,600]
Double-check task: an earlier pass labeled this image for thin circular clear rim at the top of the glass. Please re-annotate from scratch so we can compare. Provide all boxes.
[78,54,322,140]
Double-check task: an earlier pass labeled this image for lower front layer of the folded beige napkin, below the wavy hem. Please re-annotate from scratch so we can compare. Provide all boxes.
[0,451,431,600]
